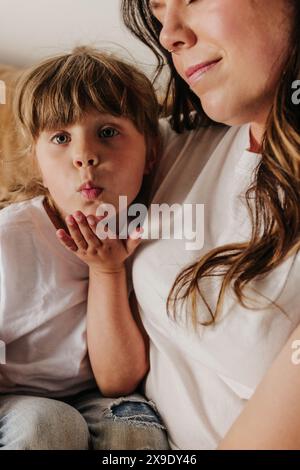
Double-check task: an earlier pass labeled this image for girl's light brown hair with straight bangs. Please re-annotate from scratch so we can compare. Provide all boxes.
[0,47,159,207]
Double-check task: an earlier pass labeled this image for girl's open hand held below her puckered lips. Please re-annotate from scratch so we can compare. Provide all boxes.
[56,211,143,273]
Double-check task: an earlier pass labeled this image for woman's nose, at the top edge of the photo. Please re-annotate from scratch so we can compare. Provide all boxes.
[159,2,197,53]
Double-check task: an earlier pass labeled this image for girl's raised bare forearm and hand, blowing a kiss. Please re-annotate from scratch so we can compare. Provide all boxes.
[57,212,148,397]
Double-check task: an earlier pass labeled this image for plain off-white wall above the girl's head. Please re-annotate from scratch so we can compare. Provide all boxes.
[0,0,163,81]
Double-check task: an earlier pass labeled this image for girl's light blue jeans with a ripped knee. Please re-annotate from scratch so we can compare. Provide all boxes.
[0,389,169,450]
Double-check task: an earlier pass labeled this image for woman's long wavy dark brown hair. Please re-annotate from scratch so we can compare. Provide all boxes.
[122,0,300,326]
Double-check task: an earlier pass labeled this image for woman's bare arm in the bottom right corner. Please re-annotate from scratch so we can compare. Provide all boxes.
[219,325,300,450]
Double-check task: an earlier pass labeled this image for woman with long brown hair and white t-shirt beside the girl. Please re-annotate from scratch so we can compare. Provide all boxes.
[122,0,300,449]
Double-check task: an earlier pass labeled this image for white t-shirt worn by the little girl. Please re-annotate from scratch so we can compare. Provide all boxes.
[0,196,95,396]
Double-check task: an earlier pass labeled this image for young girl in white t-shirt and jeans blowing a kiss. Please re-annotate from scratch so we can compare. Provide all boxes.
[0,48,167,449]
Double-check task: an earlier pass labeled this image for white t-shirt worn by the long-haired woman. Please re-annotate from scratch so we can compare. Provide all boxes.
[133,121,300,449]
